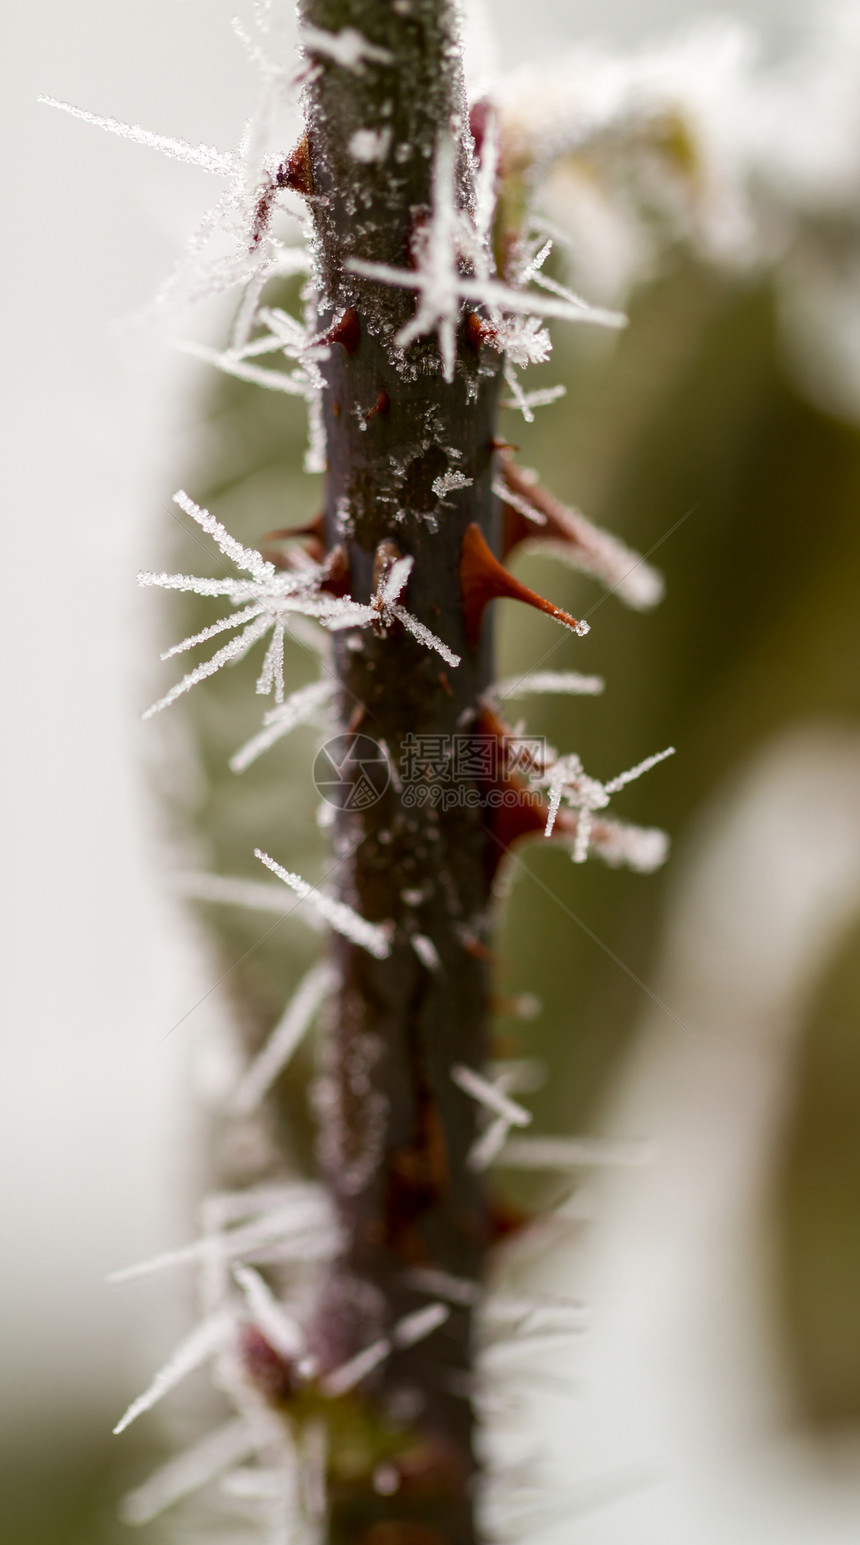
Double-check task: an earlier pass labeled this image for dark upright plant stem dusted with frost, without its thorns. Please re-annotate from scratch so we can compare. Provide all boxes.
[300,0,503,1545]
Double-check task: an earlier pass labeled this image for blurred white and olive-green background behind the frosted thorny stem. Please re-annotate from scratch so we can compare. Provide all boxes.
[0,0,860,1545]
